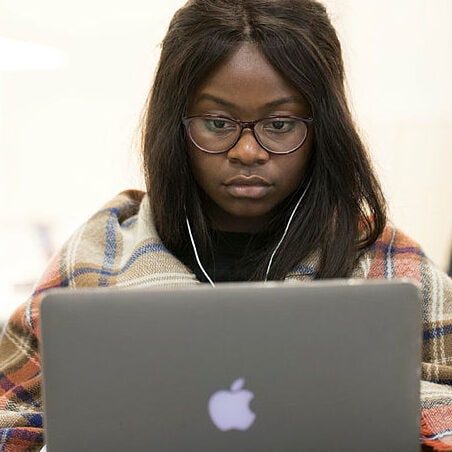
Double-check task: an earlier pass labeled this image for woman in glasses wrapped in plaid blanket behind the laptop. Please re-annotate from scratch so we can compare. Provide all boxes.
[0,0,452,450]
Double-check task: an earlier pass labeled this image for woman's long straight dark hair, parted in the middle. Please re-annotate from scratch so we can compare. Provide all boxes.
[143,0,386,279]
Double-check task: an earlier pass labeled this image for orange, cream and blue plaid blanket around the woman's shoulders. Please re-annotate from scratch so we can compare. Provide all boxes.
[0,191,452,452]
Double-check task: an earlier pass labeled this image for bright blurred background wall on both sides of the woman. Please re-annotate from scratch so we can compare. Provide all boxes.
[0,0,452,320]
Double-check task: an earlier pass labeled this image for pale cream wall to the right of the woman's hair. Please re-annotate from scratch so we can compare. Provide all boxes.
[331,0,452,274]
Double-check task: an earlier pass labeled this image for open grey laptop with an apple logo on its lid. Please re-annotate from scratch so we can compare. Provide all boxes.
[41,280,422,452]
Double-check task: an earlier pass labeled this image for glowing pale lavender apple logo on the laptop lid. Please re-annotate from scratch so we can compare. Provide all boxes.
[209,378,256,432]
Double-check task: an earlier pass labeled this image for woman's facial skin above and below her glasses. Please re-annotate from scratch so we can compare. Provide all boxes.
[189,43,312,232]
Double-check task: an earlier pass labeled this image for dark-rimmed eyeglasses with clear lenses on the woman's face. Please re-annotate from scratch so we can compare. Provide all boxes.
[182,115,313,154]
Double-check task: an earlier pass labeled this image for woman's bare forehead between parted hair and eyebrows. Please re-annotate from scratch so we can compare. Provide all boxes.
[192,43,307,114]
